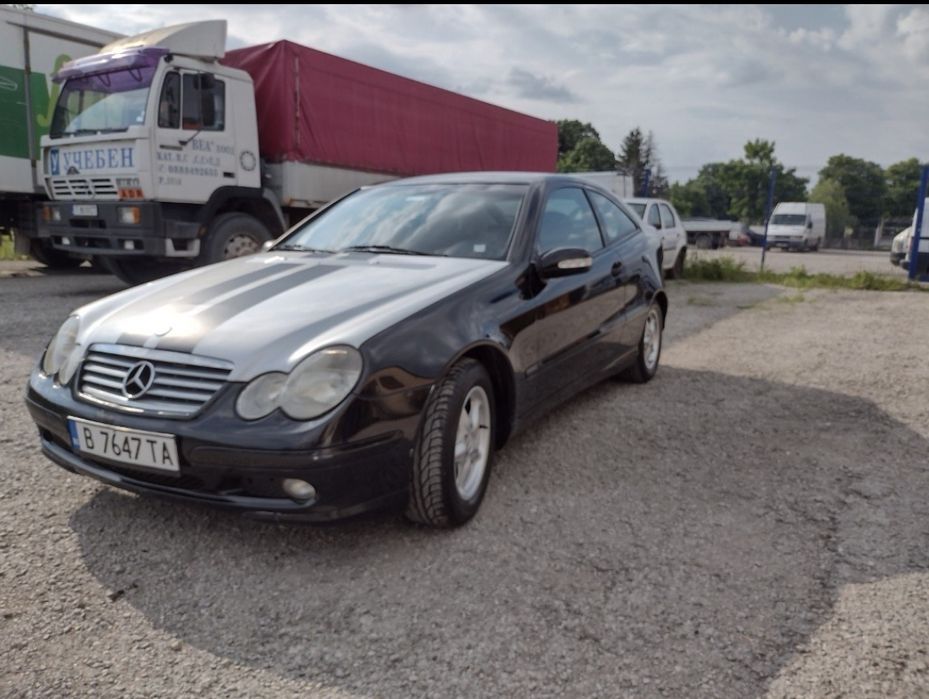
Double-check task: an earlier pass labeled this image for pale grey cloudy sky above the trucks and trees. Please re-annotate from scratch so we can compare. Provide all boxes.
[36,5,929,180]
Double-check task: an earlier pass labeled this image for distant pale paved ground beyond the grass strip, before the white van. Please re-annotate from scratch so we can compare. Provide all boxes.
[688,247,906,277]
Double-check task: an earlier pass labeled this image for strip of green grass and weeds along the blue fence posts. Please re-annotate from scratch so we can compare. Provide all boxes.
[684,257,927,292]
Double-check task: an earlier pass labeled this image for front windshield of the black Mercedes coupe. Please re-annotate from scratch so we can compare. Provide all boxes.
[275,184,528,260]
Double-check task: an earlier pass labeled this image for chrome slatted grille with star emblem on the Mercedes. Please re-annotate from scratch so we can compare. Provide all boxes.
[78,344,233,417]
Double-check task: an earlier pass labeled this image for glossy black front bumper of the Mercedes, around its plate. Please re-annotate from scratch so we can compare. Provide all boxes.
[26,375,428,522]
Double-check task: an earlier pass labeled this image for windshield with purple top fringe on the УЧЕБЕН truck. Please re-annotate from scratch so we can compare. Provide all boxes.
[49,66,155,138]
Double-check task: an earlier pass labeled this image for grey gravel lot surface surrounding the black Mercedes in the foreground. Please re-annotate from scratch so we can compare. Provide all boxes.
[0,266,929,698]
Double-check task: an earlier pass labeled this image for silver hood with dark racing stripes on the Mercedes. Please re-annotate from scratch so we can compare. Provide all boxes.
[77,252,507,381]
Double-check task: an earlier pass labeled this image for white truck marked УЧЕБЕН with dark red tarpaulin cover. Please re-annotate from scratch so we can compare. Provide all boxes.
[37,21,558,283]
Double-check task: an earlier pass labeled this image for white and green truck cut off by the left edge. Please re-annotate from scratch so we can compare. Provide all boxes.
[0,5,119,267]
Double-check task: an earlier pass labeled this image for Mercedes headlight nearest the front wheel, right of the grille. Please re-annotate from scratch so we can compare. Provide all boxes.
[236,346,362,420]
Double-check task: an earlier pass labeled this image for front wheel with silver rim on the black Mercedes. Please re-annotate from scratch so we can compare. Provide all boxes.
[406,359,494,527]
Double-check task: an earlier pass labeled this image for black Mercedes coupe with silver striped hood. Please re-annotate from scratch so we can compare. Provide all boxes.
[27,173,668,526]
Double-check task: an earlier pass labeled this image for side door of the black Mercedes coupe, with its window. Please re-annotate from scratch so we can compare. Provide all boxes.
[526,186,624,403]
